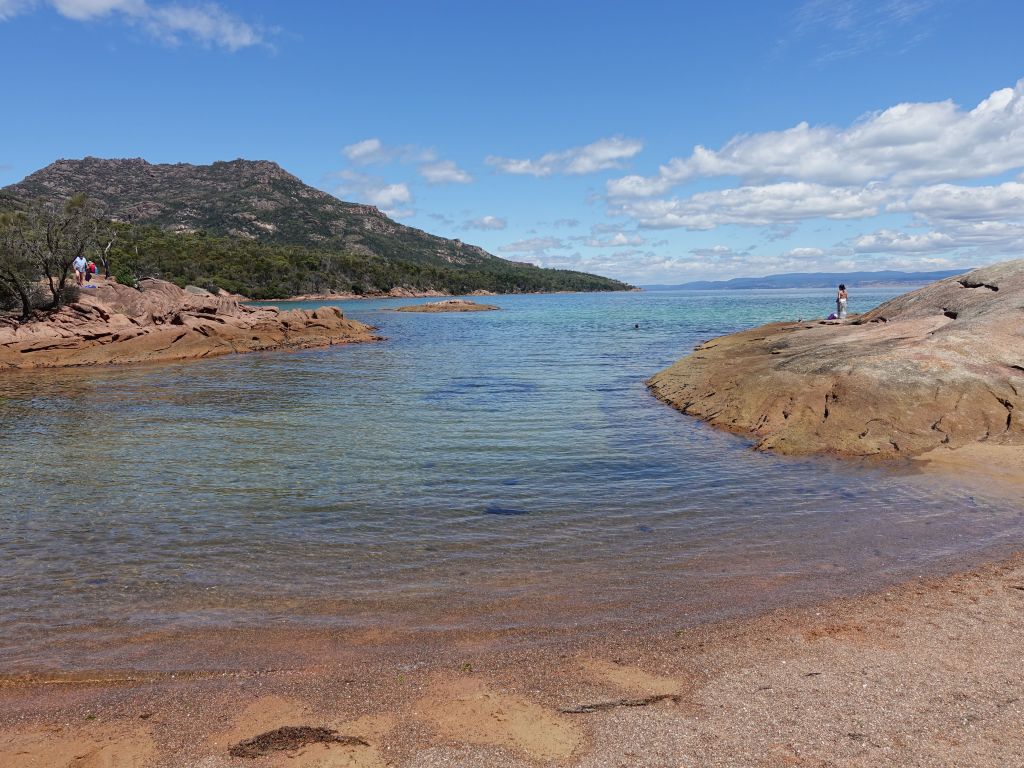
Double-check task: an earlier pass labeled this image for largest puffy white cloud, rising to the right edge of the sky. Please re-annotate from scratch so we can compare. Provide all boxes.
[607,80,1024,198]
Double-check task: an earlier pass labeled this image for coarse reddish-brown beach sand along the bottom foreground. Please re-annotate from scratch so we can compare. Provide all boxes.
[0,555,1024,768]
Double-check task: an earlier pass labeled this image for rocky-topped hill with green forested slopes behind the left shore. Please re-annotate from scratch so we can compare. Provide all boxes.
[0,158,629,296]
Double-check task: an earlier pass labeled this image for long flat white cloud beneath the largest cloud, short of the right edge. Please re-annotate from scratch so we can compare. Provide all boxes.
[613,181,893,229]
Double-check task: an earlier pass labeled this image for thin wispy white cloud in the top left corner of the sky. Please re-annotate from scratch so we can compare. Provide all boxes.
[0,0,264,51]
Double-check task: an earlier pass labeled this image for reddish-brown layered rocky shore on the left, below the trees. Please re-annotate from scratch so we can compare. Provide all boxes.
[0,279,377,370]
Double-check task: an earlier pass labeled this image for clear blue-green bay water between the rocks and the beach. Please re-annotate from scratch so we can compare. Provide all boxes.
[0,291,1024,670]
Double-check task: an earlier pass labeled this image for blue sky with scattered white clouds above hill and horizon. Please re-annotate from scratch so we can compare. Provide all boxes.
[0,0,1024,285]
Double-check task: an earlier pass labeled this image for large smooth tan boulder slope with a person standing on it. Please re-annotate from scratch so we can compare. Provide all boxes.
[647,259,1024,456]
